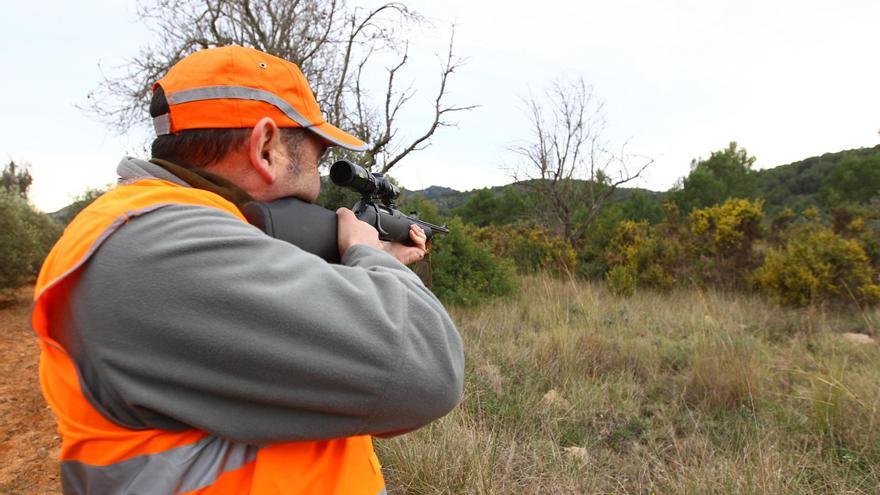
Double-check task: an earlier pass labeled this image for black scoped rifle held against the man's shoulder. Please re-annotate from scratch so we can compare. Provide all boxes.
[241,160,449,263]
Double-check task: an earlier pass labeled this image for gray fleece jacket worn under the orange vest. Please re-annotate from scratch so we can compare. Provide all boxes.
[58,158,464,444]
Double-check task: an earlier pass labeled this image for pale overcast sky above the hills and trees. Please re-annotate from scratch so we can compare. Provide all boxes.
[0,0,880,211]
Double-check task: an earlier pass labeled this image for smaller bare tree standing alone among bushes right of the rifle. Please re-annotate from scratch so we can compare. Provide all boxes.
[512,79,652,246]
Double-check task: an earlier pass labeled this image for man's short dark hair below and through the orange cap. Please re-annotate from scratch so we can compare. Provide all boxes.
[150,86,309,168]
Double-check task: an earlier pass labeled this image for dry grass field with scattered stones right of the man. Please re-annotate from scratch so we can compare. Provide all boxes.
[377,277,880,494]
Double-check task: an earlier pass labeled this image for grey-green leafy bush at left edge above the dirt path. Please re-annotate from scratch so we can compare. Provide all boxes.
[0,189,61,289]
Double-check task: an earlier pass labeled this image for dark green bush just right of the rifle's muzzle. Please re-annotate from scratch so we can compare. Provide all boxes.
[431,218,518,305]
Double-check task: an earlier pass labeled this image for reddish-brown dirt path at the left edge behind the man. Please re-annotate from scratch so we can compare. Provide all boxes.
[0,289,61,495]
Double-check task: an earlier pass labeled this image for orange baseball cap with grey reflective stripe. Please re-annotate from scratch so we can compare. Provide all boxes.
[153,46,368,151]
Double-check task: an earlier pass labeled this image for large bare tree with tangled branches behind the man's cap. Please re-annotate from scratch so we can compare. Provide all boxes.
[86,0,474,172]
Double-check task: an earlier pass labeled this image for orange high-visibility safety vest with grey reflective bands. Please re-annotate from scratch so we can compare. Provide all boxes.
[32,179,385,495]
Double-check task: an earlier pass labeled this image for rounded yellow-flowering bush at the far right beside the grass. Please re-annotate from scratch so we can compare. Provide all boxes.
[755,225,880,306]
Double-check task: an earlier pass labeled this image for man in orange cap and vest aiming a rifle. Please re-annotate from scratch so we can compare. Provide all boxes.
[33,46,463,495]
